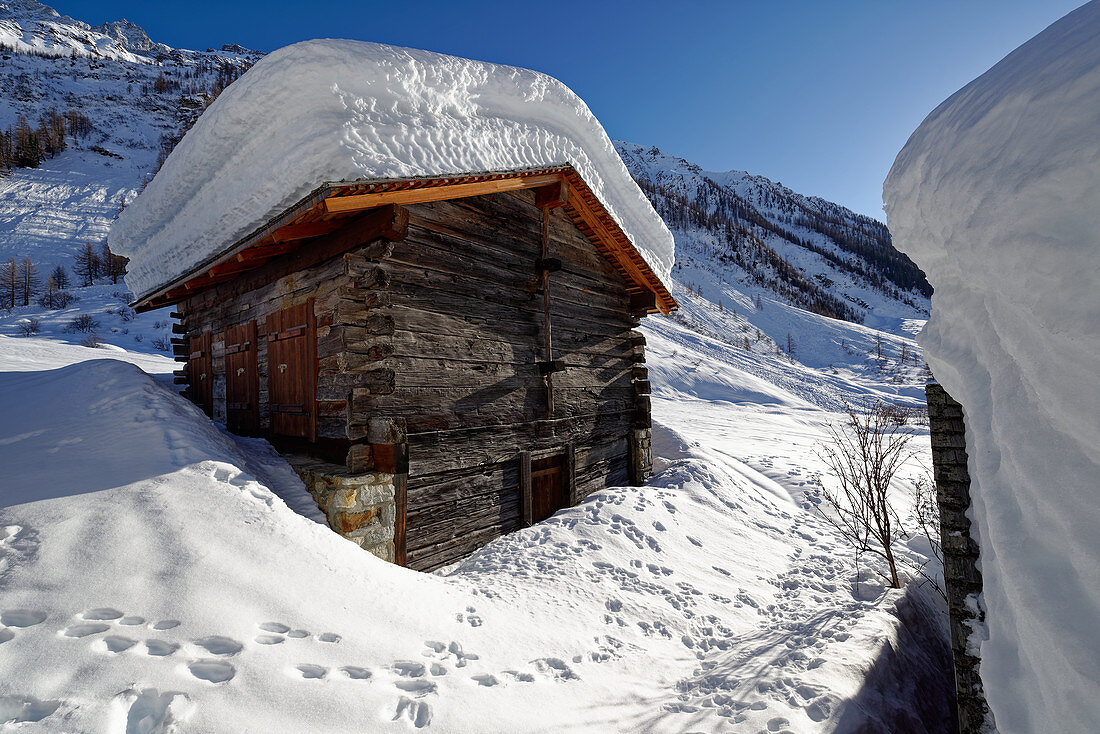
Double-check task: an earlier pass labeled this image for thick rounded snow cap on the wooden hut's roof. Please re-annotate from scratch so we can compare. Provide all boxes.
[109,40,673,296]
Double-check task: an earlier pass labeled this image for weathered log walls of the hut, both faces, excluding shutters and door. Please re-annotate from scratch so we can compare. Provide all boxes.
[180,191,649,569]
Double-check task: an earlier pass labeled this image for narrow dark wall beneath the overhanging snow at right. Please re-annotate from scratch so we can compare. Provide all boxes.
[925,383,992,734]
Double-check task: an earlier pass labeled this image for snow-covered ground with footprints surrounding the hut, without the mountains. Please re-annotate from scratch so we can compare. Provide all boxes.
[0,277,950,734]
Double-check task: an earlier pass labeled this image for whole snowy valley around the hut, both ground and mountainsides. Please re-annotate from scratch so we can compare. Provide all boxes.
[0,0,953,734]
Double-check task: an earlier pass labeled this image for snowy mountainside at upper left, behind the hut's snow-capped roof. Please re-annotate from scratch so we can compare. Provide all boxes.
[0,7,257,274]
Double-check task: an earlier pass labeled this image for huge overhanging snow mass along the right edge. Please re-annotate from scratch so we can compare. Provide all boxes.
[884,1,1100,733]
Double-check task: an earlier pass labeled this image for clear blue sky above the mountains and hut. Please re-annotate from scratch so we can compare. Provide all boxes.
[47,0,1080,224]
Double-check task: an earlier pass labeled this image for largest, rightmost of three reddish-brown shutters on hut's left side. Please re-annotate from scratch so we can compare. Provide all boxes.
[266,299,317,441]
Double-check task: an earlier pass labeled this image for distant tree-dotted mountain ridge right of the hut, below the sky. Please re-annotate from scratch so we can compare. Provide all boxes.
[615,142,932,331]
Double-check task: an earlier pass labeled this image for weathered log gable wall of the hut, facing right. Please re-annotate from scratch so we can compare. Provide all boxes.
[351,191,648,569]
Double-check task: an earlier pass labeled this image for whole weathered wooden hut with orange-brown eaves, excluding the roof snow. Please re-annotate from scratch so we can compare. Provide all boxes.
[135,166,675,570]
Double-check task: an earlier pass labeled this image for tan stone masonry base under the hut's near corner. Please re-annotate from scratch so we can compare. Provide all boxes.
[287,457,396,562]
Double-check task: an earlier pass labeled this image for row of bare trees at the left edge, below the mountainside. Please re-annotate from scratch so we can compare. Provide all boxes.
[0,242,129,309]
